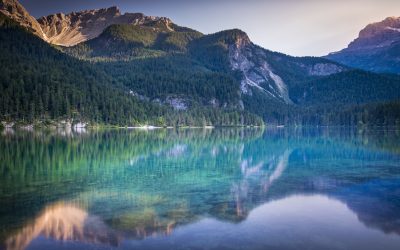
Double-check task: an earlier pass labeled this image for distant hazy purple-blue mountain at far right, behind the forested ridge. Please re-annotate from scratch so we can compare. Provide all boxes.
[326,17,400,74]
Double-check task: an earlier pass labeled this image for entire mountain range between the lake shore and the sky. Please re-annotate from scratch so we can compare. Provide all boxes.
[0,0,400,126]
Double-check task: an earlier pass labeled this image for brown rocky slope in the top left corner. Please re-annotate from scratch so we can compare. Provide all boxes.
[0,0,47,40]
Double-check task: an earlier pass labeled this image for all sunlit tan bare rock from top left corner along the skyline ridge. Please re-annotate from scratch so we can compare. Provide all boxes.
[0,0,174,46]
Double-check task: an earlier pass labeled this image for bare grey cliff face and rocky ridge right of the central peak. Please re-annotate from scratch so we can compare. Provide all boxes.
[229,32,346,104]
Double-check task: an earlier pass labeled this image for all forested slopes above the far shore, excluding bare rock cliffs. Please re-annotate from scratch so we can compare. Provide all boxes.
[0,9,400,125]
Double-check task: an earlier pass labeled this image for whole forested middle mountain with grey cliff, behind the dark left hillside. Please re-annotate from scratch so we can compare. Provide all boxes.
[61,24,400,123]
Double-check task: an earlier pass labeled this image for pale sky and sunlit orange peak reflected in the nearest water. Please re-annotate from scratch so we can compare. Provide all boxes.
[7,195,400,250]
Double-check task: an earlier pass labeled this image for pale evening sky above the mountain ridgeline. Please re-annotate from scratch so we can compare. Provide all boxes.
[20,0,400,56]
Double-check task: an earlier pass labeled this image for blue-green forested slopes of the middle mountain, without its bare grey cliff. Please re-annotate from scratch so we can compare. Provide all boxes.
[61,25,400,124]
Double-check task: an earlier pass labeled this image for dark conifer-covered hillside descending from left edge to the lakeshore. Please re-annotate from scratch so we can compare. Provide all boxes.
[0,15,260,126]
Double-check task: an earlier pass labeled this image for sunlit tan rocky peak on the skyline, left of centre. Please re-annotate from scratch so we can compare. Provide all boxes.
[38,7,173,46]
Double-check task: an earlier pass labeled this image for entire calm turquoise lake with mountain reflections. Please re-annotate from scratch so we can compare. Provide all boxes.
[0,128,400,250]
